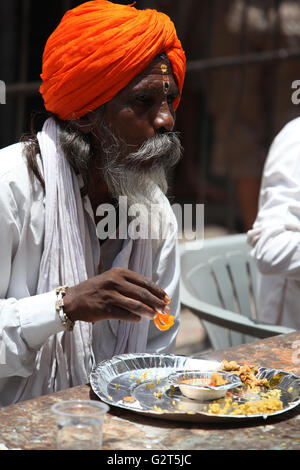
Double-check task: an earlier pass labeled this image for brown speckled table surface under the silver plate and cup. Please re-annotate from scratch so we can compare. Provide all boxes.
[0,332,300,451]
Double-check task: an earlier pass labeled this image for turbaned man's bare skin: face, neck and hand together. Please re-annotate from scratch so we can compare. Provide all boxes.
[64,59,179,322]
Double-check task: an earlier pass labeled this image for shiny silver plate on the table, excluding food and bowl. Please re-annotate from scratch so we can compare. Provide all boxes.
[90,354,300,422]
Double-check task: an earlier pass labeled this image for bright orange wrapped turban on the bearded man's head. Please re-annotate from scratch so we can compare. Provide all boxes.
[40,0,186,120]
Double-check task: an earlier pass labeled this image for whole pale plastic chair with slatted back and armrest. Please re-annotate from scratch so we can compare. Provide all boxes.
[180,234,294,349]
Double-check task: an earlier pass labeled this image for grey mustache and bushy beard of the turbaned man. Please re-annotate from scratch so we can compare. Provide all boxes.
[94,122,183,206]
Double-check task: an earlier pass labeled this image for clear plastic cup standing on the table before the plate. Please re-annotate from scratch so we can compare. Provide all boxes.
[52,400,109,450]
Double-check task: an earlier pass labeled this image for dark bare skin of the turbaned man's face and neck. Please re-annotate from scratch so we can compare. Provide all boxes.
[89,59,179,213]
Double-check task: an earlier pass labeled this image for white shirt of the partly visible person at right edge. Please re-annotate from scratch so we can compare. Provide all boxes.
[248,118,300,330]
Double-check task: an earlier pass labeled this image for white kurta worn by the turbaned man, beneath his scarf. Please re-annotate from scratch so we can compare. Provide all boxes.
[0,143,180,406]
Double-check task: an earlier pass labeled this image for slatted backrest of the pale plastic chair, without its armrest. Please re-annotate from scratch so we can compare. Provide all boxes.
[181,234,258,349]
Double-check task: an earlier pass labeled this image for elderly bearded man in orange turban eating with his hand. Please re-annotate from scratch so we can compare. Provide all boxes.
[0,0,185,406]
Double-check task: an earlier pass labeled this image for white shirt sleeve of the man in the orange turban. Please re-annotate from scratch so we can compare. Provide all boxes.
[0,177,63,378]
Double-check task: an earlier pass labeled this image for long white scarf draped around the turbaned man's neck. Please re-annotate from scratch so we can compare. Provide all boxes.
[17,118,152,400]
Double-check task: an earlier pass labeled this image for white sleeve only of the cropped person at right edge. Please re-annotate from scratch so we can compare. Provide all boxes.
[248,118,300,279]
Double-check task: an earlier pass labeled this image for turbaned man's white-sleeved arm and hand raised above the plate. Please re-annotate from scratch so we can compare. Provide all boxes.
[0,181,173,378]
